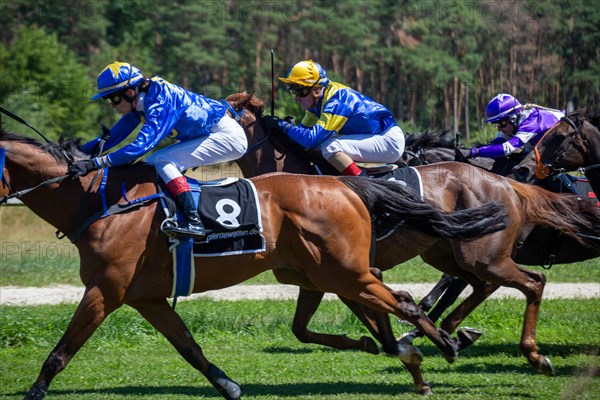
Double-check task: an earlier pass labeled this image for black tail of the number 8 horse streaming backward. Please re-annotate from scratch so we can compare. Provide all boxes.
[340,177,508,240]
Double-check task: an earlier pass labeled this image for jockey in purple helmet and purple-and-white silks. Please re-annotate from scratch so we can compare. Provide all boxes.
[467,93,564,158]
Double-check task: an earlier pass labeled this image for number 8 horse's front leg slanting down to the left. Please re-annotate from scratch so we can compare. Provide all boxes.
[24,287,121,400]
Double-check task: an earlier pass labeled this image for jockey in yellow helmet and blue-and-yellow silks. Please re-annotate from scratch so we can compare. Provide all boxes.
[264,60,404,175]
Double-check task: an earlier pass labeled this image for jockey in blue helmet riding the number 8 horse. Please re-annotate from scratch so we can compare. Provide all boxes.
[69,62,248,237]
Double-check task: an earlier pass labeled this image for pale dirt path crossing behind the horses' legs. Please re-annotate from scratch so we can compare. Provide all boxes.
[0,283,600,306]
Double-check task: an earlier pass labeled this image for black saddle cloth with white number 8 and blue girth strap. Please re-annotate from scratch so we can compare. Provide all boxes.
[169,178,266,297]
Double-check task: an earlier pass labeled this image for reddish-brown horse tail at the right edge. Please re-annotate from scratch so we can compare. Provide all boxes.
[509,179,600,246]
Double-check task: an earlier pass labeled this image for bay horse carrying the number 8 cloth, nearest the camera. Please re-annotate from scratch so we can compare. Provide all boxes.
[0,131,507,400]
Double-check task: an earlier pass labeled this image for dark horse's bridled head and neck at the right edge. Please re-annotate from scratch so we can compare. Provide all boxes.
[513,111,600,196]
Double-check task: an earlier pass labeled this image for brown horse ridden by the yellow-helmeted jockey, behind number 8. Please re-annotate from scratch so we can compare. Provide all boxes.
[228,94,600,382]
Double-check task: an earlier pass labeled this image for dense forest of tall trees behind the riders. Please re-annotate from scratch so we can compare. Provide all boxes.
[0,0,600,144]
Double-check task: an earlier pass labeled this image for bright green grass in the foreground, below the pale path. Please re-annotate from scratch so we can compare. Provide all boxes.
[0,299,600,400]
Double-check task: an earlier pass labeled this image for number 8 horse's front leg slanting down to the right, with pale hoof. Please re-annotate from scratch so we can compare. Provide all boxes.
[130,299,242,400]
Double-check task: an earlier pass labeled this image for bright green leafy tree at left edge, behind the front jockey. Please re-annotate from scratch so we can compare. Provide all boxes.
[0,27,97,139]
